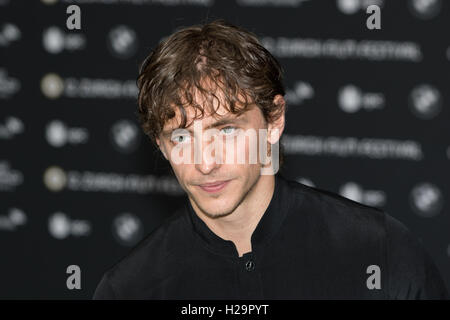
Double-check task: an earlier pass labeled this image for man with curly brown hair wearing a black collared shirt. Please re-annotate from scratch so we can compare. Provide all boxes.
[94,20,447,299]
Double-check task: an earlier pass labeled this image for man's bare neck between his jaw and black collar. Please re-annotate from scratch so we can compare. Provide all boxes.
[190,175,275,256]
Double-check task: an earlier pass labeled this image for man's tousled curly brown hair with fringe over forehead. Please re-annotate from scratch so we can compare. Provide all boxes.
[137,19,285,142]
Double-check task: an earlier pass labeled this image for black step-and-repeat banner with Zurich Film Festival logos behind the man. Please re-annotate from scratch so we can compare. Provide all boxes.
[0,0,450,299]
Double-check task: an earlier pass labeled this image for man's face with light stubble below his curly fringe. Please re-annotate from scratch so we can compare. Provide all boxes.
[157,94,284,218]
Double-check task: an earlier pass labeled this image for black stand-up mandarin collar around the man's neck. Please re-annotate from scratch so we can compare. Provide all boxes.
[186,173,289,257]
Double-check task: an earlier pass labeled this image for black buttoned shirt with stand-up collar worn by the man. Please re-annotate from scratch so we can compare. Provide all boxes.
[93,174,448,299]
